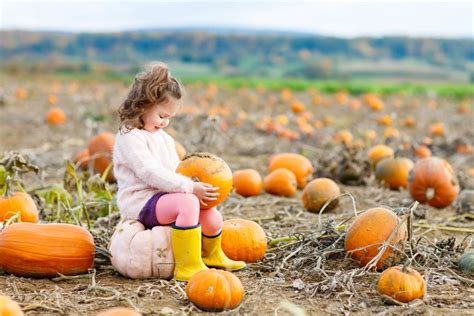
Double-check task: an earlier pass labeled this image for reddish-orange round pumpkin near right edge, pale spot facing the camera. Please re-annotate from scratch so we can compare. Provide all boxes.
[408,157,459,208]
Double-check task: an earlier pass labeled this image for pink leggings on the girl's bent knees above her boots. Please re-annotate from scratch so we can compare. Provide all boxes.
[155,193,222,236]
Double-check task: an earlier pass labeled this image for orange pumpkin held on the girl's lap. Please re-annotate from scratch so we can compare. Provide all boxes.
[176,153,232,209]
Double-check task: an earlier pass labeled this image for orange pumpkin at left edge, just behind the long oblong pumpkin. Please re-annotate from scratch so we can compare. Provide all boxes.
[0,192,38,223]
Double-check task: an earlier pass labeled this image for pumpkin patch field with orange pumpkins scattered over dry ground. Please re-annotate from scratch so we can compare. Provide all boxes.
[0,76,474,315]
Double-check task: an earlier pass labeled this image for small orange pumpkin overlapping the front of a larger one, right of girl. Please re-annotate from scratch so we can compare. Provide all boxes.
[263,168,297,197]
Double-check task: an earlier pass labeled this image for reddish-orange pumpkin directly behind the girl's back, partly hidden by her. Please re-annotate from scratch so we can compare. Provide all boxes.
[88,132,115,181]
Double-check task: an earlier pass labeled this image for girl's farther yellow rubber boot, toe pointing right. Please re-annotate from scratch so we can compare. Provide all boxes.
[202,233,246,271]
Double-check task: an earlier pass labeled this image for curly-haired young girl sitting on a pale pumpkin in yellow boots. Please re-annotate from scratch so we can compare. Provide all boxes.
[113,63,245,281]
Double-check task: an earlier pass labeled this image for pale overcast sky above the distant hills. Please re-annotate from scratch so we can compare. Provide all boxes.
[0,0,474,37]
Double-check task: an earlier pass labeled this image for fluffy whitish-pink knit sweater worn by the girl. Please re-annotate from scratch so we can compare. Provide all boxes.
[113,129,193,219]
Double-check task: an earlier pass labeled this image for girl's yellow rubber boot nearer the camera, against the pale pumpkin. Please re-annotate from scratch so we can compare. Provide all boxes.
[171,225,208,281]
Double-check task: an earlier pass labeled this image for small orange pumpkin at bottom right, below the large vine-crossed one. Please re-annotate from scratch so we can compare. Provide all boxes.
[377,266,425,303]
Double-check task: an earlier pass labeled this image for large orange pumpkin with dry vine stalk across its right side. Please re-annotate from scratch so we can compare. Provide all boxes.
[344,207,407,269]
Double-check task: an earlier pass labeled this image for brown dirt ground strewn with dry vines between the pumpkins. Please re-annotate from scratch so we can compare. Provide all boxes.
[0,76,474,315]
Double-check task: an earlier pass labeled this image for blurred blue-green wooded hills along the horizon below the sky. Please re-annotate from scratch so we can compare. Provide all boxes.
[0,28,474,81]
